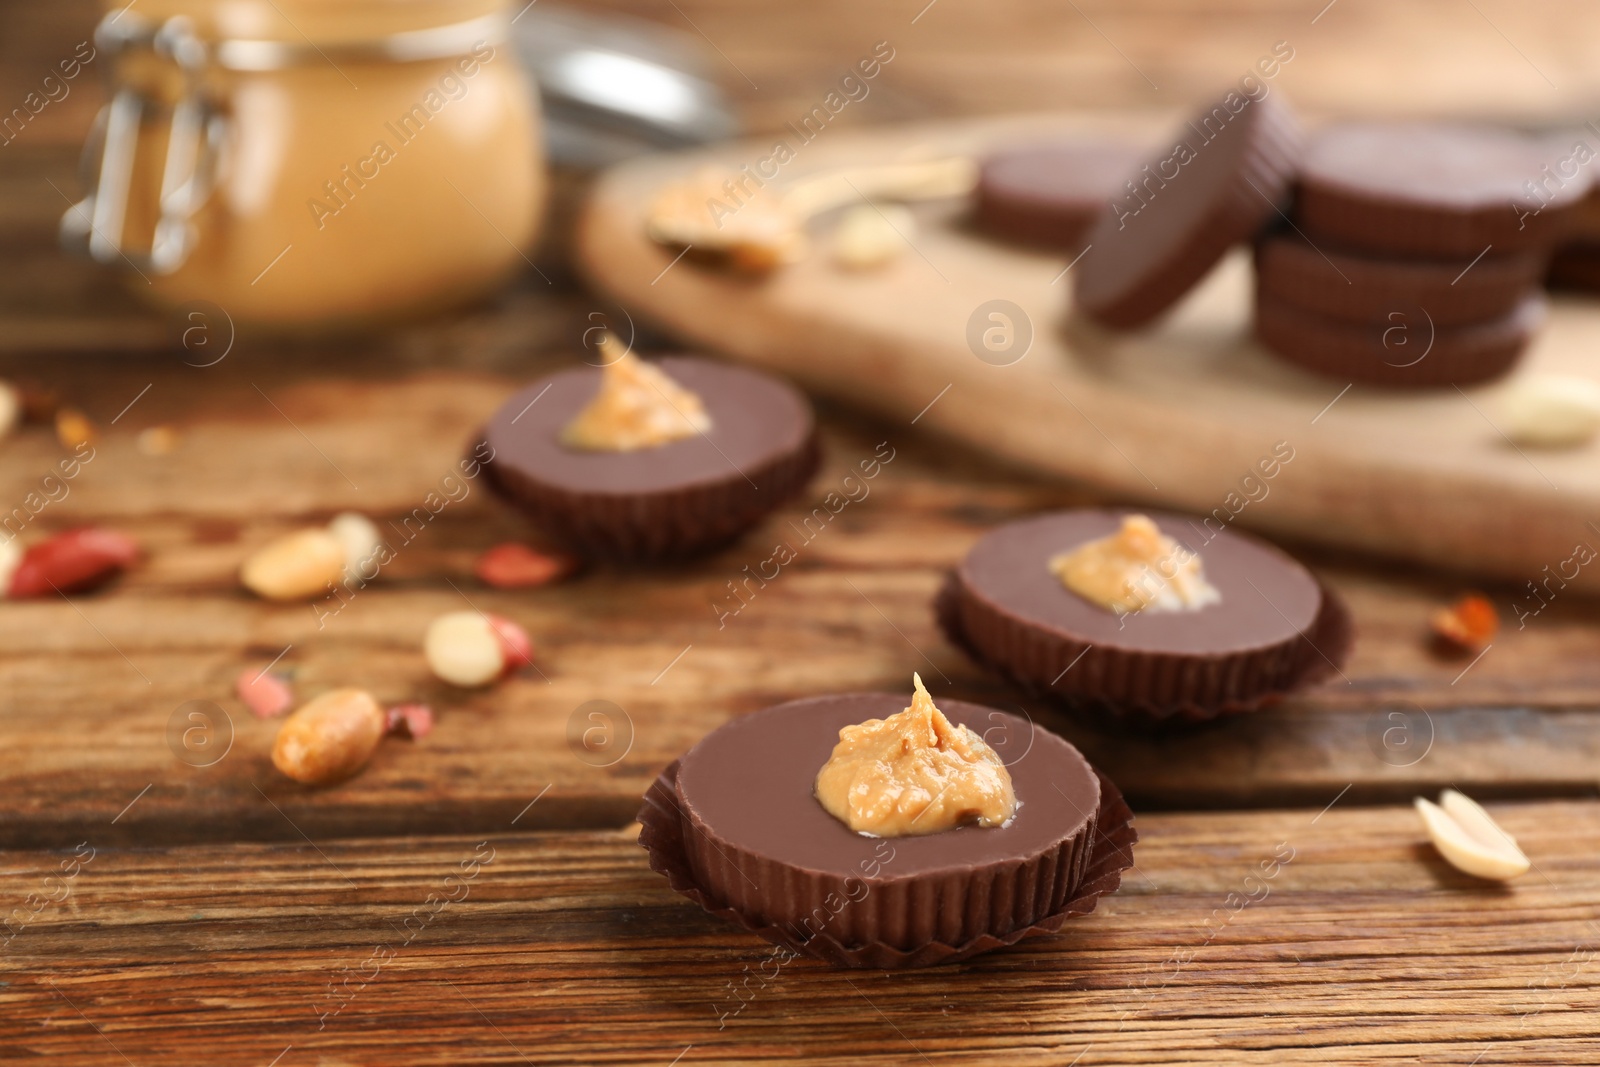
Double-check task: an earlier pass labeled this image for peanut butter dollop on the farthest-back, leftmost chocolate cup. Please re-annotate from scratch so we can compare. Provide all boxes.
[562,334,710,453]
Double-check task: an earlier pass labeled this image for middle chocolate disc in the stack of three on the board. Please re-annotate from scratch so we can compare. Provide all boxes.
[1256,234,1544,328]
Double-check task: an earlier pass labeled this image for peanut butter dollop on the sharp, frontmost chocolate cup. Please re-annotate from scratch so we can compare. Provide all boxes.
[816,675,1018,837]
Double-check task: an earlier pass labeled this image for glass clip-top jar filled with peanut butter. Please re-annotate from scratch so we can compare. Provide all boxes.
[61,0,546,328]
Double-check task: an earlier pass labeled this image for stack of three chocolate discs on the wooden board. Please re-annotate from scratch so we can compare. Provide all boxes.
[1256,123,1587,387]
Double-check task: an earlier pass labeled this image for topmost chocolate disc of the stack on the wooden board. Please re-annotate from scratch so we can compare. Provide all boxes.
[1294,123,1589,259]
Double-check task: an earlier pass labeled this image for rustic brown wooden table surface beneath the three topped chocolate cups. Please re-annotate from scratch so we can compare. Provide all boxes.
[0,0,1600,1067]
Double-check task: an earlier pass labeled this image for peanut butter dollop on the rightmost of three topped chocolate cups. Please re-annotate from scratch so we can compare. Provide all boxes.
[1050,515,1222,614]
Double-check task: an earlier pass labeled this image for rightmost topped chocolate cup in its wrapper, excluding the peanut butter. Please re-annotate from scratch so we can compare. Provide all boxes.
[936,509,1349,720]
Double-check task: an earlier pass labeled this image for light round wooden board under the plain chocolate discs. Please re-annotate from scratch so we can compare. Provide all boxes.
[579,115,1600,601]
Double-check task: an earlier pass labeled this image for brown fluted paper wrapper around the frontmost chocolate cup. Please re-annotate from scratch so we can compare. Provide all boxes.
[638,761,1139,969]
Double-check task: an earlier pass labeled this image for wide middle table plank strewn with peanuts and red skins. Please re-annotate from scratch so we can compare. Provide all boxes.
[9,350,1600,845]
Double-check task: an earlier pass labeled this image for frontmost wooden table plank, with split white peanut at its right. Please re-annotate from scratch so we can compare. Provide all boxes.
[0,801,1600,1067]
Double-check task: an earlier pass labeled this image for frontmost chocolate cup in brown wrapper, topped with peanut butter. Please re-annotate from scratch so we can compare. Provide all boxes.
[640,691,1136,966]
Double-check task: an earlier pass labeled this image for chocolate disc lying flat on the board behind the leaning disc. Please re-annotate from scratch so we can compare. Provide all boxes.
[973,139,1141,251]
